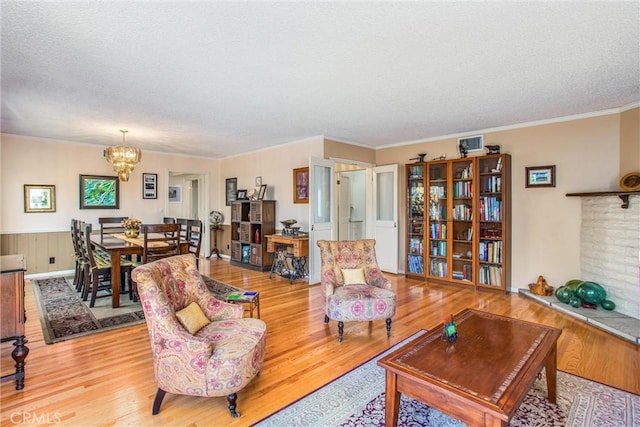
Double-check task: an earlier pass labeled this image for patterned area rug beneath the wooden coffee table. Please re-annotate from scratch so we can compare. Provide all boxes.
[254,331,640,427]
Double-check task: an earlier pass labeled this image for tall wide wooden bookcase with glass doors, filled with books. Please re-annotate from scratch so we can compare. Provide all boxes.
[405,154,511,291]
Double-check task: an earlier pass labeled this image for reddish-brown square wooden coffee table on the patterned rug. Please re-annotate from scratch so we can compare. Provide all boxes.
[378,309,562,427]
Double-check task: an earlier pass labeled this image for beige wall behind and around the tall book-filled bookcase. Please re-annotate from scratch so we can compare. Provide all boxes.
[376,114,620,288]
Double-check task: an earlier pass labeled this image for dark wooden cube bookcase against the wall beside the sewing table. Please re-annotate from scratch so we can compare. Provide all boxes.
[231,200,276,271]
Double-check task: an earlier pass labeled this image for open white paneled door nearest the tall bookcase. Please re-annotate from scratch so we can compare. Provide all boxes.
[373,165,398,274]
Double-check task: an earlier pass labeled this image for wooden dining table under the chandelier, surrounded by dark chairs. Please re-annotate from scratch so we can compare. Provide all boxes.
[91,234,189,308]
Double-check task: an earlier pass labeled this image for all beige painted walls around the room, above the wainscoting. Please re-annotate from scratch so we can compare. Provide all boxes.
[0,109,639,288]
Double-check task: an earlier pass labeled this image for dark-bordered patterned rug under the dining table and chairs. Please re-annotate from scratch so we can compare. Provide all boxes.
[33,276,240,344]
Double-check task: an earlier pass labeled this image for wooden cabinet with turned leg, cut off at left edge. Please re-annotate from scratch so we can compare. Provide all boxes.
[0,255,29,390]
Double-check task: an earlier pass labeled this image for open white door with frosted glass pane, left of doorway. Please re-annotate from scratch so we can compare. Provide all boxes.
[309,157,338,285]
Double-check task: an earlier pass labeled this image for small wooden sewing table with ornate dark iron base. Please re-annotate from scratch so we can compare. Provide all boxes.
[264,234,309,283]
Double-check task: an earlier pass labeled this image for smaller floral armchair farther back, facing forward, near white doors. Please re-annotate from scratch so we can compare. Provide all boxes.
[317,239,396,342]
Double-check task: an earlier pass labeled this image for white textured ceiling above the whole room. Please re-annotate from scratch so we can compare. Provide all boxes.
[0,0,640,158]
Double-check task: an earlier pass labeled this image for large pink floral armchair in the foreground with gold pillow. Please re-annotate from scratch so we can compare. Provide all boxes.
[131,254,266,417]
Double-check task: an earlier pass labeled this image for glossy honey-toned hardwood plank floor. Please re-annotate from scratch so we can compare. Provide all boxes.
[0,260,640,426]
